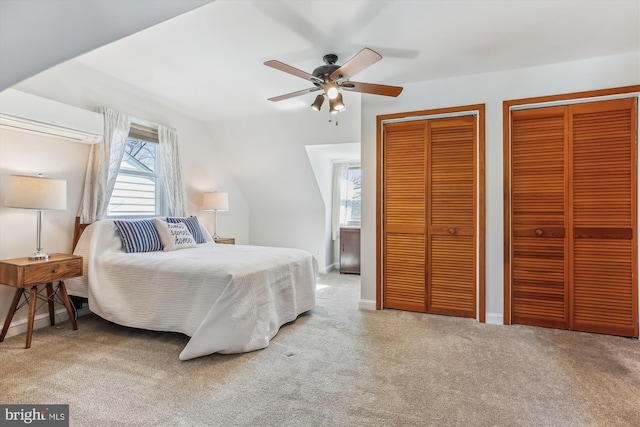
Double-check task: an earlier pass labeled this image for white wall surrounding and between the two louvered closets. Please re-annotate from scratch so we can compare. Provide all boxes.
[361,52,640,323]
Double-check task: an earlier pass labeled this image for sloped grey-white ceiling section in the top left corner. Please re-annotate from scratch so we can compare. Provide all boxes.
[0,0,212,90]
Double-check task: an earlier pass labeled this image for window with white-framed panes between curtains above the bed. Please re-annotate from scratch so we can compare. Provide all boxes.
[107,124,162,217]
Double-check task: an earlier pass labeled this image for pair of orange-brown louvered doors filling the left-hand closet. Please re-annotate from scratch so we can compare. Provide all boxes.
[382,116,477,317]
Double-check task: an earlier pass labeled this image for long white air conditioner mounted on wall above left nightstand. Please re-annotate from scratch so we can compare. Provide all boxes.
[0,89,103,144]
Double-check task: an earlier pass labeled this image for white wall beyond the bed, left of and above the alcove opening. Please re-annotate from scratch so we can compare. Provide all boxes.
[209,93,361,267]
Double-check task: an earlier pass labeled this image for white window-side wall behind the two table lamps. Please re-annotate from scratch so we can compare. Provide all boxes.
[0,63,250,334]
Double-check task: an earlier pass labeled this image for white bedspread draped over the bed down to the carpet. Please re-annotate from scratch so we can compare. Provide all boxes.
[65,220,318,360]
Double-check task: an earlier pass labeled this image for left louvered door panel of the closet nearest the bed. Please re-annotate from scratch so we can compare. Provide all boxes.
[383,122,426,312]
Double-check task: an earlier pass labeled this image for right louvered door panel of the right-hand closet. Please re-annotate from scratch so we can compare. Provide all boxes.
[570,99,638,337]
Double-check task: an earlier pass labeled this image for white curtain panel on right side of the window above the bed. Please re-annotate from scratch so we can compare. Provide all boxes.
[158,125,187,216]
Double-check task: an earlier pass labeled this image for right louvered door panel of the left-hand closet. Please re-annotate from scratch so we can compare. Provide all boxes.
[427,116,476,317]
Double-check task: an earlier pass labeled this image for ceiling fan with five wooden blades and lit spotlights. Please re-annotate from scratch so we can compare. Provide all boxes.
[264,47,402,114]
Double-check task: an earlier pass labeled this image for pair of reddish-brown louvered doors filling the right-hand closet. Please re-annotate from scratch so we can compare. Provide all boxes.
[511,99,638,337]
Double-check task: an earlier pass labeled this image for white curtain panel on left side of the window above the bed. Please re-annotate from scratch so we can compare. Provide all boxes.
[78,107,131,223]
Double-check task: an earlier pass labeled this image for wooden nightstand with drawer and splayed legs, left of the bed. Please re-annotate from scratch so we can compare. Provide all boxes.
[0,254,82,348]
